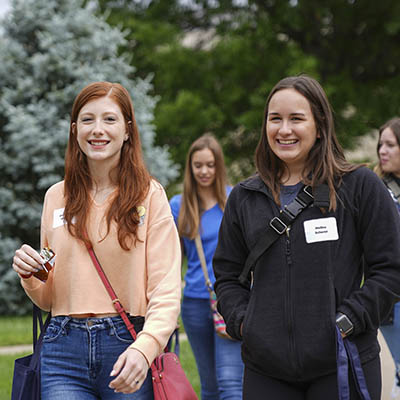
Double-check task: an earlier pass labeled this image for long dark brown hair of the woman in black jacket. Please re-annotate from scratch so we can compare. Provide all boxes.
[255,75,358,210]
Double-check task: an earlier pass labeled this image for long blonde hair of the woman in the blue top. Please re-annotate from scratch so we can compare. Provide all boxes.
[178,134,227,240]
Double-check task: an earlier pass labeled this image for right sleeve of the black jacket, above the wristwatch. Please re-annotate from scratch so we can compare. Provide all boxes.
[338,170,400,335]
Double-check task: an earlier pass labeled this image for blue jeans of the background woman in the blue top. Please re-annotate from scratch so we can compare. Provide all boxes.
[181,297,244,400]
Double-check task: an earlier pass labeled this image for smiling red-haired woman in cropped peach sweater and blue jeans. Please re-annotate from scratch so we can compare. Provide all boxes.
[13,82,180,400]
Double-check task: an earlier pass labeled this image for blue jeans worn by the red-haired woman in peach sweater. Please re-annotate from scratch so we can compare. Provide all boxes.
[41,316,154,400]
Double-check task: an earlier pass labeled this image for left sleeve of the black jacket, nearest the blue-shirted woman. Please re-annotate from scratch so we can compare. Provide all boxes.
[213,187,250,340]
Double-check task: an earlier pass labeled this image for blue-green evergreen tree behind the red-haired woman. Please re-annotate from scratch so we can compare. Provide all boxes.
[0,0,177,314]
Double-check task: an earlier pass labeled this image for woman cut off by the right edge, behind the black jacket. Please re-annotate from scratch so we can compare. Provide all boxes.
[375,118,400,399]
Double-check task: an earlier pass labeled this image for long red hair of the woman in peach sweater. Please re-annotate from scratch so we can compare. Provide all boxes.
[64,82,151,250]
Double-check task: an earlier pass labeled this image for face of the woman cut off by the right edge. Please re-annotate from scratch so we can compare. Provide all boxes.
[378,128,400,178]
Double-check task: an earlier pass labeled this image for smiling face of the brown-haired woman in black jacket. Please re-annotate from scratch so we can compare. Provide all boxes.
[266,89,319,177]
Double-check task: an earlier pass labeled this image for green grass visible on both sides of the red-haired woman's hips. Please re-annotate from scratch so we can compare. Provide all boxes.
[0,316,200,400]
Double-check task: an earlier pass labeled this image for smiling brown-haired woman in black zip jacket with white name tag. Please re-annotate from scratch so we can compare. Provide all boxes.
[214,75,400,400]
